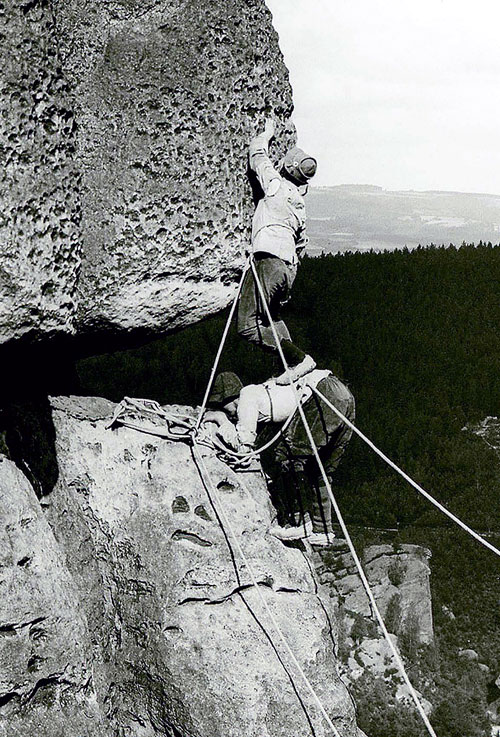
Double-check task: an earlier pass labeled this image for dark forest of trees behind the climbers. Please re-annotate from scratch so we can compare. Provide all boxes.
[78,243,500,737]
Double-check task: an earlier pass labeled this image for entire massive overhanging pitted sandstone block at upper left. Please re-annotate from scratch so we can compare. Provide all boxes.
[0,0,293,342]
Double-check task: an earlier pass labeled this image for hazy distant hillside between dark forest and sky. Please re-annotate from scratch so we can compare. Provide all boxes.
[307,184,500,256]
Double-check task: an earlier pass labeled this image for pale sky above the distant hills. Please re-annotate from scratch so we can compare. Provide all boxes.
[266,0,500,195]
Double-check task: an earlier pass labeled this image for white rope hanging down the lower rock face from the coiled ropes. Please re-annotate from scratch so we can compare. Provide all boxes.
[189,435,340,737]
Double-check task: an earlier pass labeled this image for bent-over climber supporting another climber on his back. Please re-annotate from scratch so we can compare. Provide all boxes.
[204,369,355,545]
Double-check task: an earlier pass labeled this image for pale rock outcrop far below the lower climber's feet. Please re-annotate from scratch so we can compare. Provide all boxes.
[315,540,434,711]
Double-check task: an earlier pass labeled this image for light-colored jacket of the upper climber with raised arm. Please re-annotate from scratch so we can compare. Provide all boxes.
[249,135,308,264]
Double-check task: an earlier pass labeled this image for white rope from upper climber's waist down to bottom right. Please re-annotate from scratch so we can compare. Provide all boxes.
[250,261,437,737]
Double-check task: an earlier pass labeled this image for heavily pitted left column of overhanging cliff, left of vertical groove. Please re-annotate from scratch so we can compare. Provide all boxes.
[0,0,81,343]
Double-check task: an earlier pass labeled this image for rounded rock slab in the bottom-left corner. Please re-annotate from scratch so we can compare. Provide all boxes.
[0,456,105,737]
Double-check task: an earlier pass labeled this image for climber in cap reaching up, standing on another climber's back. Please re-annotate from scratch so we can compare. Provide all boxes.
[238,119,317,384]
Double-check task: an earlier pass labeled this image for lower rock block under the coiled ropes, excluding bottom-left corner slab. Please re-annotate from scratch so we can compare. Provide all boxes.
[43,397,360,737]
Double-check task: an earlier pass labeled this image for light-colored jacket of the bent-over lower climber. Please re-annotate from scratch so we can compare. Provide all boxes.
[236,369,331,445]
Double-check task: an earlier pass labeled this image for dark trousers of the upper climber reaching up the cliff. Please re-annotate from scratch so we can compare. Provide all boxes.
[238,254,305,366]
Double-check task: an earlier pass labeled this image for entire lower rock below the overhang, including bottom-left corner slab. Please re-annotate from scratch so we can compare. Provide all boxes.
[0,397,360,737]
